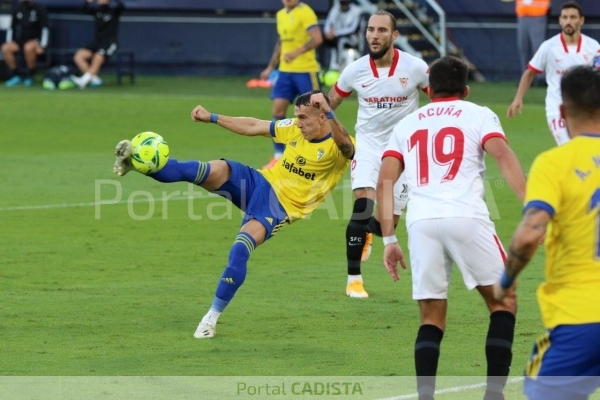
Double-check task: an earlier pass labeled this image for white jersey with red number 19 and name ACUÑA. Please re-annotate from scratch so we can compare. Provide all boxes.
[383,97,505,226]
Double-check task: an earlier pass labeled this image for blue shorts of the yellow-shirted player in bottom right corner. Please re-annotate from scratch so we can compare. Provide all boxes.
[523,323,600,400]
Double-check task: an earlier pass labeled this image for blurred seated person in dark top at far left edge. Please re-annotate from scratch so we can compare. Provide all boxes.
[2,0,49,86]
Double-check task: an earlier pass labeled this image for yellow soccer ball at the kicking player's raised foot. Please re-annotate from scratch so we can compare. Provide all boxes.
[131,132,169,174]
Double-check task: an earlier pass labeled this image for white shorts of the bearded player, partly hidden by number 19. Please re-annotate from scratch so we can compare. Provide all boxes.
[350,149,408,215]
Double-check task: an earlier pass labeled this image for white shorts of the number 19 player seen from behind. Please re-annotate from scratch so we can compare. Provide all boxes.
[408,218,506,300]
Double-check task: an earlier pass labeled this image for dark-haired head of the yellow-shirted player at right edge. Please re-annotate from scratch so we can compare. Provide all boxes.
[560,65,600,119]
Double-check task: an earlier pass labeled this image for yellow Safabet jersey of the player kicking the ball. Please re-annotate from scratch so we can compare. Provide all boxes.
[258,118,355,223]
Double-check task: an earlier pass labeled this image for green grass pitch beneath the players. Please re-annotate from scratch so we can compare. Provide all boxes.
[0,77,592,393]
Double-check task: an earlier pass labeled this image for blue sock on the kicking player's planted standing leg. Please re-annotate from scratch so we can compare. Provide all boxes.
[210,232,256,312]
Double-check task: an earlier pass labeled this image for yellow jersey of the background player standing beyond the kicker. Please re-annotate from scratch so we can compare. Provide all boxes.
[277,3,320,72]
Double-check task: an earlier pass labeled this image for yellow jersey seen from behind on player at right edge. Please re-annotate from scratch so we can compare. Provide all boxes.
[525,133,600,329]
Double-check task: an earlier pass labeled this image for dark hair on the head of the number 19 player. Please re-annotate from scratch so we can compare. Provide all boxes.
[429,56,469,98]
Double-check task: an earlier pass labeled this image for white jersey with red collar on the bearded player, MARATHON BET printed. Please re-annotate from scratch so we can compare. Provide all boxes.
[334,49,429,154]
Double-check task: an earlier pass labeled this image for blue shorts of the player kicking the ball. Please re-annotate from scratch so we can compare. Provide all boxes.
[214,160,288,240]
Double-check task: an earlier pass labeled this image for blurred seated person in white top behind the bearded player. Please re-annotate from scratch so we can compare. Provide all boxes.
[323,0,364,71]
